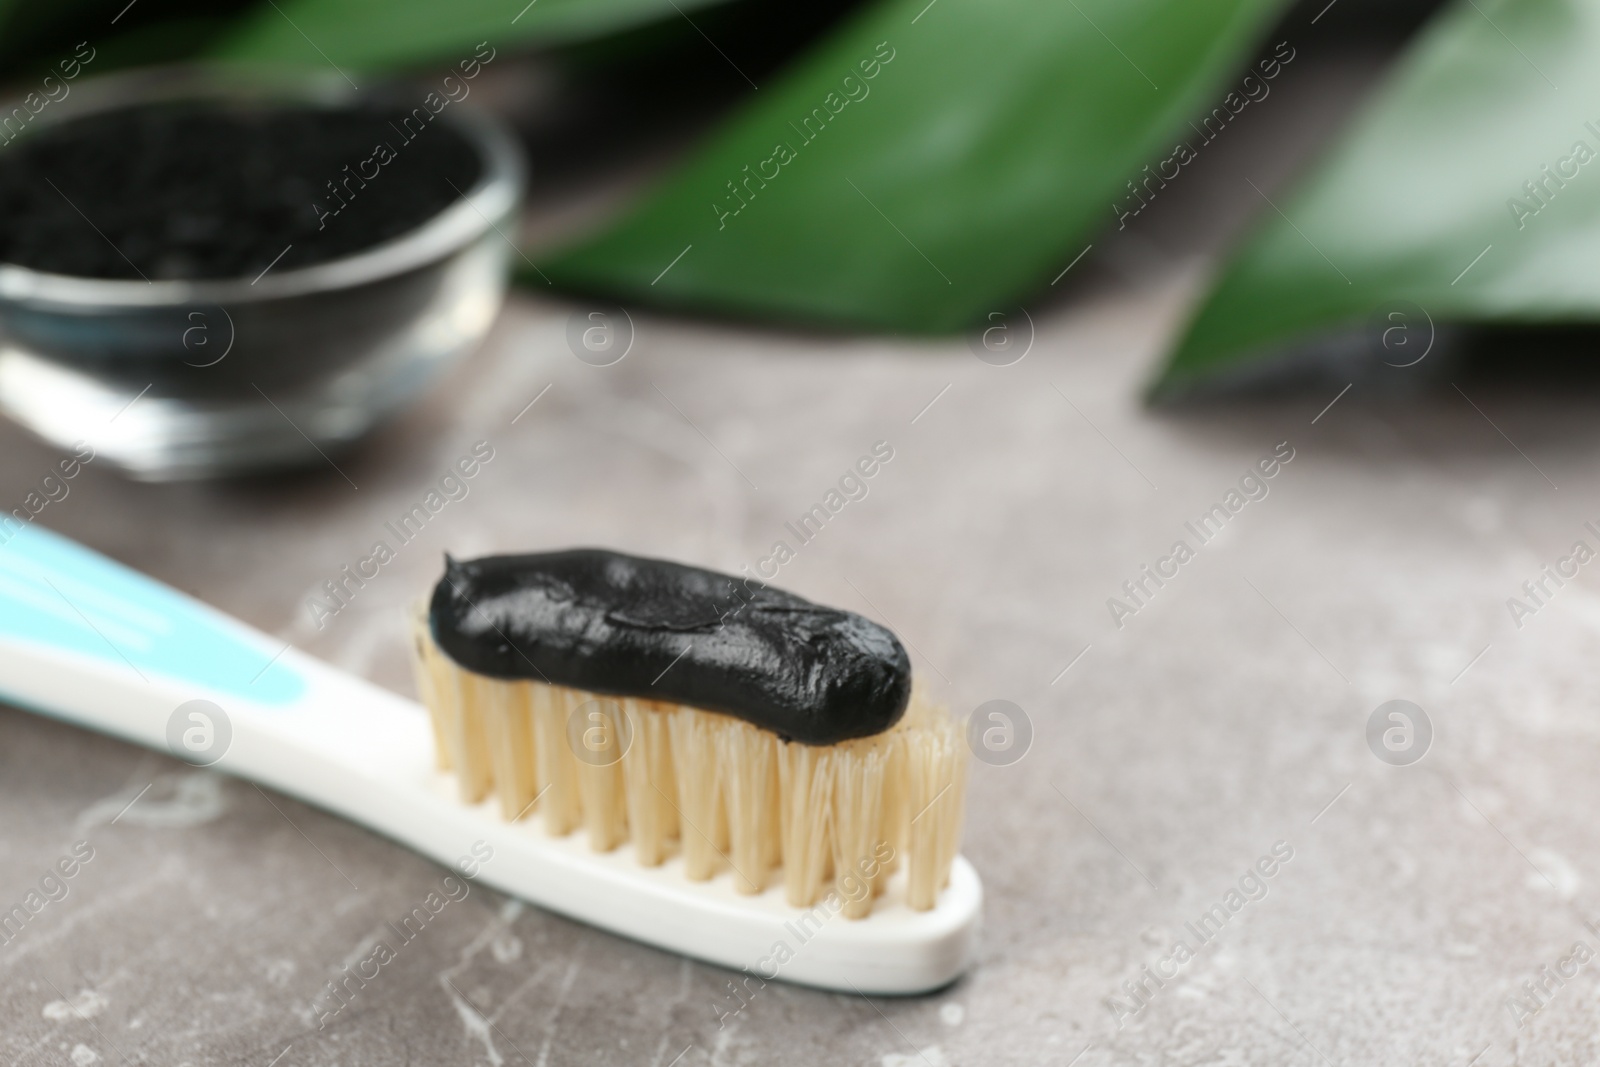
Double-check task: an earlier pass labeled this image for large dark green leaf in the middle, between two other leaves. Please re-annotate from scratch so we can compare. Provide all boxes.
[541,0,1283,331]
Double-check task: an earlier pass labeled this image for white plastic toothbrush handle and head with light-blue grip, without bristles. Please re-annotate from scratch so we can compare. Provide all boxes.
[0,525,982,993]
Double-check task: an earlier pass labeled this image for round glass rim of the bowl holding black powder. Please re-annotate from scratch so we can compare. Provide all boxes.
[0,64,526,312]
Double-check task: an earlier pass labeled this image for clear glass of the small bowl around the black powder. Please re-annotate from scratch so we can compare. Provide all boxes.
[0,69,525,482]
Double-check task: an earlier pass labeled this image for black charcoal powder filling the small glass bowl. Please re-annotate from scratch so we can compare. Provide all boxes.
[0,99,483,282]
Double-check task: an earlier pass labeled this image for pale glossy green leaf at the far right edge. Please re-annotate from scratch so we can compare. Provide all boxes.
[1154,0,1600,395]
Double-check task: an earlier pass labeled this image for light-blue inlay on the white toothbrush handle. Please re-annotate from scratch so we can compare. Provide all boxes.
[0,525,306,704]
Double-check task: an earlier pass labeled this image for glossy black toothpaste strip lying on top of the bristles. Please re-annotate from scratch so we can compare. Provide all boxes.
[429,549,910,745]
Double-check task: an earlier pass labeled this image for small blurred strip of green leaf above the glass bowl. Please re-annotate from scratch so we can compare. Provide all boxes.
[203,0,739,74]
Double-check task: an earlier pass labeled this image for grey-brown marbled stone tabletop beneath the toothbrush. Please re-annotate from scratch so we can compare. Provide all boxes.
[0,45,1600,1067]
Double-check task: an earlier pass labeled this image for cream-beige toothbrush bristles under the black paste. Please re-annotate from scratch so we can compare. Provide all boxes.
[411,611,966,918]
